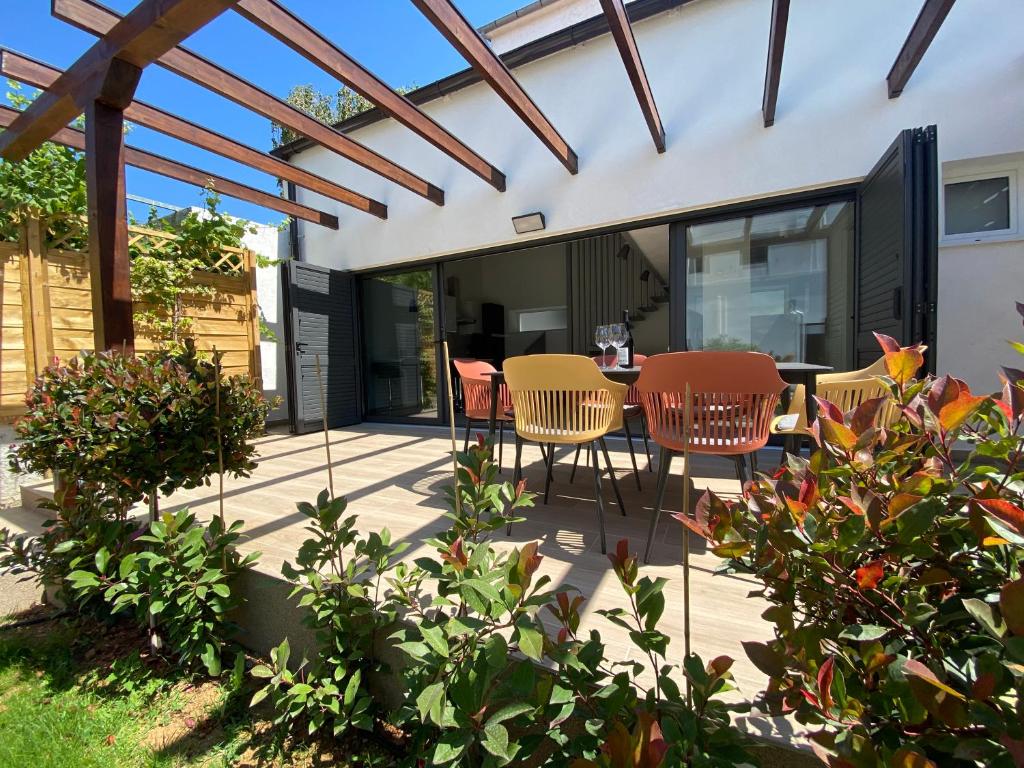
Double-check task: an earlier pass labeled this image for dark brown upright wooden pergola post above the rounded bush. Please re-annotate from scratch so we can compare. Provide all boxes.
[85,58,142,353]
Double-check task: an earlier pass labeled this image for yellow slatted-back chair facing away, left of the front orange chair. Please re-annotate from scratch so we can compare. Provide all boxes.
[503,354,629,552]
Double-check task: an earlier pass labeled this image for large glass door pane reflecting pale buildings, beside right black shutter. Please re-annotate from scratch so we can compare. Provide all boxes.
[677,201,855,370]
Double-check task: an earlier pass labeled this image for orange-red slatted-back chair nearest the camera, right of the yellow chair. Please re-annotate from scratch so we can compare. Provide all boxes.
[636,352,785,562]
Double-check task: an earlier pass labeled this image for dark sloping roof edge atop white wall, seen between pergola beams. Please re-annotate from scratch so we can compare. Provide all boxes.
[270,0,694,160]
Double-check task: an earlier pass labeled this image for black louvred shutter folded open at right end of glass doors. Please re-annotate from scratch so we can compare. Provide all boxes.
[854,126,938,371]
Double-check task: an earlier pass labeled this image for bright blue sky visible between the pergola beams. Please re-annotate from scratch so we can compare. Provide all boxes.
[0,0,526,223]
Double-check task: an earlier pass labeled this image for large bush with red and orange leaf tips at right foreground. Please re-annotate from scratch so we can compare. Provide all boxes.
[684,327,1024,768]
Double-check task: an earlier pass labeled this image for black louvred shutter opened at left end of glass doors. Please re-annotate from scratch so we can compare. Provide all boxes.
[289,261,361,433]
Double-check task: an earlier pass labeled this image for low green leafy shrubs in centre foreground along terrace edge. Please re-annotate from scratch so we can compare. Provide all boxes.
[260,442,753,768]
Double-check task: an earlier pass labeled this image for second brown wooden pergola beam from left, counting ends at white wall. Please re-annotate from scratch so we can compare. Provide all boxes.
[0,48,387,219]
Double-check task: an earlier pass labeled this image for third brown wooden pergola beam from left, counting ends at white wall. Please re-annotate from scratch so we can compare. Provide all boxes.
[52,0,444,205]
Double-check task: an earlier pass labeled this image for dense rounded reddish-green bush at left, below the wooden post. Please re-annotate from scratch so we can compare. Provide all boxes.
[10,340,269,507]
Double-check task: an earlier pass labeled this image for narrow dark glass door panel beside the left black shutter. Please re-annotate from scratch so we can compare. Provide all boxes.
[360,267,440,428]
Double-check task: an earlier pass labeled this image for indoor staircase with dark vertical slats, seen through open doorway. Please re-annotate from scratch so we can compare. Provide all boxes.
[569,233,669,354]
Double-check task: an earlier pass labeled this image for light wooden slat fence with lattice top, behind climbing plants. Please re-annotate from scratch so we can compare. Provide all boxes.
[0,219,260,420]
